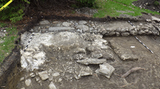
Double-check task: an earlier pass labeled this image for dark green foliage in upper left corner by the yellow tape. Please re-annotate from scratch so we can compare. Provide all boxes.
[0,0,30,22]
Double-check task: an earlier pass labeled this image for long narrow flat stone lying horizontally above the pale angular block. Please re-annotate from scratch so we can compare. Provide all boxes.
[77,58,106,65]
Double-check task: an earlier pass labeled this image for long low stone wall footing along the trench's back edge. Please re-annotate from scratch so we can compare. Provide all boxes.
[31,19,159,36]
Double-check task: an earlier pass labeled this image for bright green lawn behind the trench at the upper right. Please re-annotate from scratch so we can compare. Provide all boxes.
[94,0,160,18]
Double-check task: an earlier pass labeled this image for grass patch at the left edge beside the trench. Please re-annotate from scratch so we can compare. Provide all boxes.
[0,23,18,64]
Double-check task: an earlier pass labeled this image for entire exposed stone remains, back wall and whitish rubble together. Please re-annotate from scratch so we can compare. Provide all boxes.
[17,17,159,89]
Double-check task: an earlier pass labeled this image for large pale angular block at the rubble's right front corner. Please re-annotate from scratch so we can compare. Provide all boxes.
[95,63,115,78]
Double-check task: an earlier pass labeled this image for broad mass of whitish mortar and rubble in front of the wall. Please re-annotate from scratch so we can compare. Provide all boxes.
[21,29,115,88]
